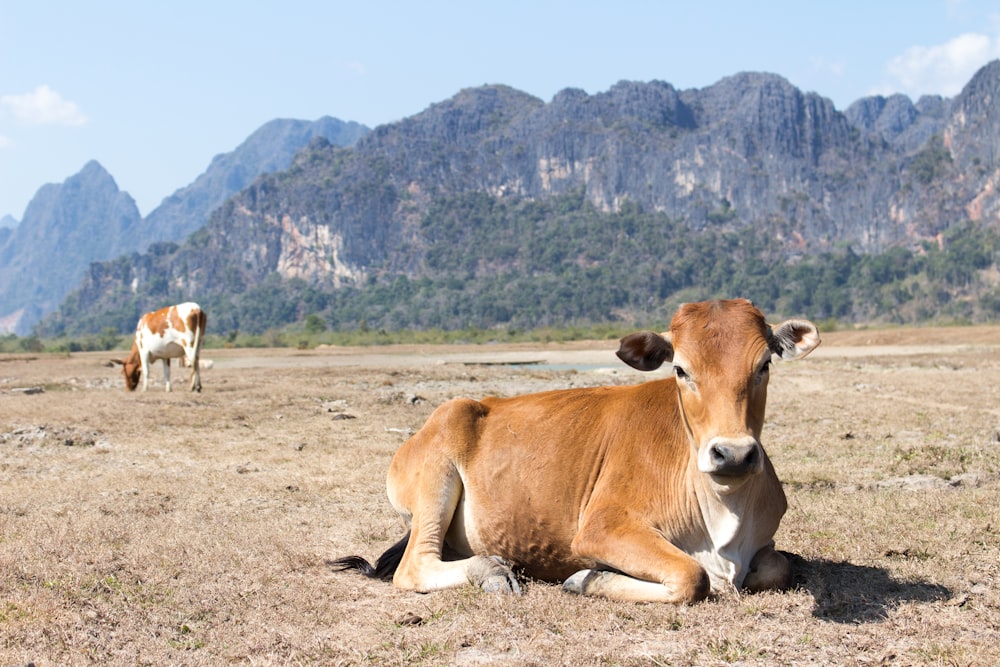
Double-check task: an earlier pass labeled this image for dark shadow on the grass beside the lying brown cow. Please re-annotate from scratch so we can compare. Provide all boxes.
[785,553,952,623]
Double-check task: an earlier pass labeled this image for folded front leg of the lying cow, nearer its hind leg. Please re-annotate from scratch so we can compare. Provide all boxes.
[563,519,711,603]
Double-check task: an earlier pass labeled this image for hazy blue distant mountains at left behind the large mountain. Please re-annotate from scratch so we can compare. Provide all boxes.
[0,117,367,335]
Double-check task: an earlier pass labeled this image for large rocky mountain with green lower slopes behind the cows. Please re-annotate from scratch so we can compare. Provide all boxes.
[42,61,1000,333]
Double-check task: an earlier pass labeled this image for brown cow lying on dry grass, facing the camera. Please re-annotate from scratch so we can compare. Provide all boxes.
[332,300,820,603]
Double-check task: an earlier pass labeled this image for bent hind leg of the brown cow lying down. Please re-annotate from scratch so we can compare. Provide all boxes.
[388,400,520,593]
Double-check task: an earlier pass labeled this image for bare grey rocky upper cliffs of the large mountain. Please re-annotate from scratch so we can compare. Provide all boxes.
[35,62,1000,334]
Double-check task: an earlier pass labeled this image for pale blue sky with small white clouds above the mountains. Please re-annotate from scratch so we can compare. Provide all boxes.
[0,0,1000,219]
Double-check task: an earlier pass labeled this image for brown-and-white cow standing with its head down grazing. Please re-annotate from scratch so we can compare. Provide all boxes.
[112,302,207,391]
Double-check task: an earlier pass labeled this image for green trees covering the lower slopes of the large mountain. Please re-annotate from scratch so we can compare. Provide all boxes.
[35,193,1000,342]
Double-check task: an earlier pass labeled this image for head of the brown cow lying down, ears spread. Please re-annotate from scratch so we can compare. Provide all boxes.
[618,299,820,484]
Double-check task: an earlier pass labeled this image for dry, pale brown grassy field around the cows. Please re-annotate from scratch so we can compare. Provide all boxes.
[0,327,1000,667]
